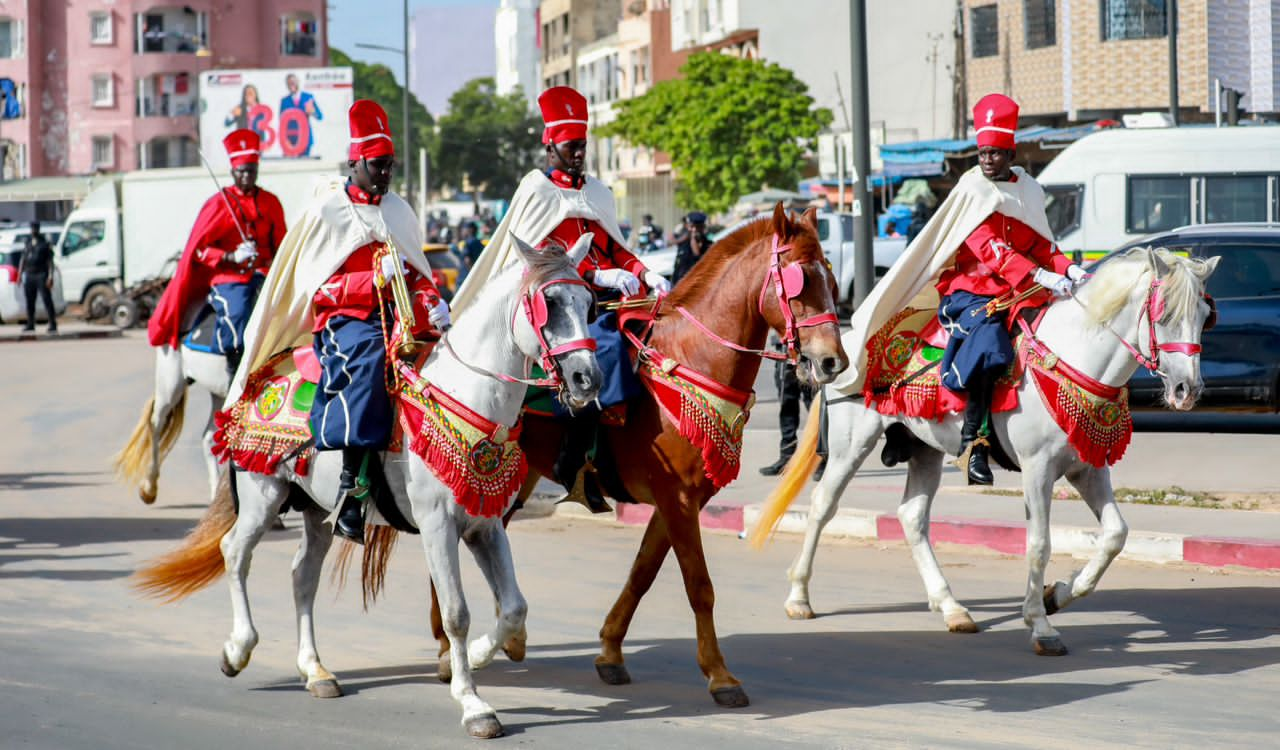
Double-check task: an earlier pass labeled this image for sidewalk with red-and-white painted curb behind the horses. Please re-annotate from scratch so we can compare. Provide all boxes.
[524,417,1280,570]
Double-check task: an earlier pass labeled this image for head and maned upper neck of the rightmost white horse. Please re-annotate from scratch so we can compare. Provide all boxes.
[1088,247,1219,411]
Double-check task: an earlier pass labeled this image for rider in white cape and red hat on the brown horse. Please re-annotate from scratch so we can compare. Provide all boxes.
[453,86,671,512]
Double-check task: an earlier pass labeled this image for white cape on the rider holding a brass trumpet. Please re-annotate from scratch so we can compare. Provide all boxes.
[225,178,431,406]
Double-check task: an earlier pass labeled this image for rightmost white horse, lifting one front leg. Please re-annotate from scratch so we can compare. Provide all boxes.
[786,248,1219,655]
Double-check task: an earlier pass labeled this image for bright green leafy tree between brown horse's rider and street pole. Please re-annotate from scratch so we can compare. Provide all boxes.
[599,52,831,211]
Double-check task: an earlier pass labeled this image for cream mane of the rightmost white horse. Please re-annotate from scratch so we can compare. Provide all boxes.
[1085,247,1207,324]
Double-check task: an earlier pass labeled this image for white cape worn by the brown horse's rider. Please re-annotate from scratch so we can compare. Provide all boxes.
[449,169,627,315]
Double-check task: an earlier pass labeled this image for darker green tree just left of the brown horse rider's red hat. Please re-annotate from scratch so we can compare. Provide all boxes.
[431,78,543,196]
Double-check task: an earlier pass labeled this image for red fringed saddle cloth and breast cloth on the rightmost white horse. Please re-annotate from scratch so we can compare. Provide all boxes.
[863,308,1133,467]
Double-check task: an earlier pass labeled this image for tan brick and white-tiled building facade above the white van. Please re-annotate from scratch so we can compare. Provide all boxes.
[964,0,1280,124]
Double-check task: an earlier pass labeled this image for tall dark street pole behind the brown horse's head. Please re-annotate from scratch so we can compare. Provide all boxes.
[849,0,876,306]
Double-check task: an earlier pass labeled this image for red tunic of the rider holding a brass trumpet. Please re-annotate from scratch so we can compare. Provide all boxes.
[311,183,440,335]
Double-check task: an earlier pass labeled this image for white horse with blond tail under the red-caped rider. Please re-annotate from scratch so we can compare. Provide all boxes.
[114,332,230,506]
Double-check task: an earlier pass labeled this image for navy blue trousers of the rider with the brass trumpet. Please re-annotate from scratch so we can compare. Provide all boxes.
[311,315,392,451]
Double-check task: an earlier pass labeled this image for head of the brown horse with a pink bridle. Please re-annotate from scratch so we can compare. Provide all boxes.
[759,202,849,384]
